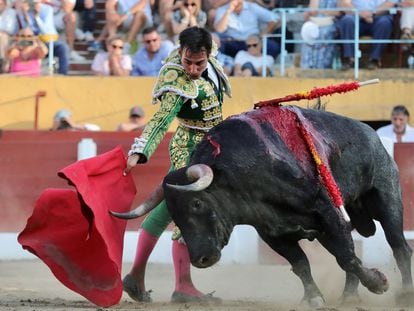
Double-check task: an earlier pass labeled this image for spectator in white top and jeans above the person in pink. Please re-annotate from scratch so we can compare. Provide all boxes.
[15,0,69,75]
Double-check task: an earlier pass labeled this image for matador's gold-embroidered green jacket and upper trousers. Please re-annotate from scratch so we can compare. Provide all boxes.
[128,49,231,169]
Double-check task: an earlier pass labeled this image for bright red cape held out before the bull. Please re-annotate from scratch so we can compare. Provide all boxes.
[18,147,136,307]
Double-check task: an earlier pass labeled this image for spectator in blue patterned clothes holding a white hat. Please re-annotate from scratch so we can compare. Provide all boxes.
[300,0,340,69]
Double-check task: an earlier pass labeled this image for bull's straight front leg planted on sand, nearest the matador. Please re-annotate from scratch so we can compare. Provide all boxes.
[262,236,325,308]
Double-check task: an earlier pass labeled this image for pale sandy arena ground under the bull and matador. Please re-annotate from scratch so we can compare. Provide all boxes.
[0,260,414,311]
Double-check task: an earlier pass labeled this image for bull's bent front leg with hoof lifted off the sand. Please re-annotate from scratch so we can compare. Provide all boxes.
[318,204,388,294]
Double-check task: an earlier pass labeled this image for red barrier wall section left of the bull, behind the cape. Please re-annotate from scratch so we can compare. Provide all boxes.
[0,131,171,232]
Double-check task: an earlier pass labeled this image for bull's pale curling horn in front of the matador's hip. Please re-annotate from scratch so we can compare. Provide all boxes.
[167,164,214,191]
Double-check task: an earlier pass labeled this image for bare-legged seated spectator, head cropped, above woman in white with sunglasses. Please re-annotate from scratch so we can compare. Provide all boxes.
[95,0,152,54]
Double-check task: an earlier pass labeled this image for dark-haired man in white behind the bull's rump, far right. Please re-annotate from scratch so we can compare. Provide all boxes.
[377,105,414,143]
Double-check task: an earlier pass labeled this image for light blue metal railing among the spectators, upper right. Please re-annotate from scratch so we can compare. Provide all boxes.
[262,7,414,79]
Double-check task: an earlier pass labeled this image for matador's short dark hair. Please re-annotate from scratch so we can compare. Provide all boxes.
[178,26,213,55]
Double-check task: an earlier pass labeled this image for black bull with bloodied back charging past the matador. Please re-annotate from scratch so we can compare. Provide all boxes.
[111,107,413,305]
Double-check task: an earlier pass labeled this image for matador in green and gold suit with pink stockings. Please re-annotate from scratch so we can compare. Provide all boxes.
[119,26,230,303]
